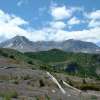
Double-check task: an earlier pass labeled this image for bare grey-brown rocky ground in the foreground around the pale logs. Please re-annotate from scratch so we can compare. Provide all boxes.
[0,66,100,100]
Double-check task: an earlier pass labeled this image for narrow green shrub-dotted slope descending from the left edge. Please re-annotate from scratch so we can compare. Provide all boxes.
[0,48,41,65]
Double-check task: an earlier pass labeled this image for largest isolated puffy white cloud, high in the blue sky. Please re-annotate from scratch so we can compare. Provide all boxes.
[51,6,72,20]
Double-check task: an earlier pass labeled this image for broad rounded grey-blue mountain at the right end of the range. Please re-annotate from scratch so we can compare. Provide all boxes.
[62,39,100,53]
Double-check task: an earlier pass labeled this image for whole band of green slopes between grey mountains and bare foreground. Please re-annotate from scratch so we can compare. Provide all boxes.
[0,49,100,77]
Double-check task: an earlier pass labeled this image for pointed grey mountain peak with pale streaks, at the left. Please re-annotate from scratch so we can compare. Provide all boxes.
[0,36,33,52]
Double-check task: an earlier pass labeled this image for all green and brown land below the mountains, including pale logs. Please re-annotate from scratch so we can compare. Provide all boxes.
[0,49,100,100]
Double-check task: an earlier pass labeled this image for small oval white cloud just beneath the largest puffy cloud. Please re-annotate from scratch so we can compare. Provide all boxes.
[50,21,66,29]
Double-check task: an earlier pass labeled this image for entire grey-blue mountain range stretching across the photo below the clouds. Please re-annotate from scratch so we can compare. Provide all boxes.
[0,36,100,53]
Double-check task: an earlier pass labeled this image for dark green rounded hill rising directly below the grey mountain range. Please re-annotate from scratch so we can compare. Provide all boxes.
[24,49,100,64]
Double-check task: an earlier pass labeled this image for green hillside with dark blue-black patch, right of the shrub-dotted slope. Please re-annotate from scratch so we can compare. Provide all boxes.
[25,49,100,78]
